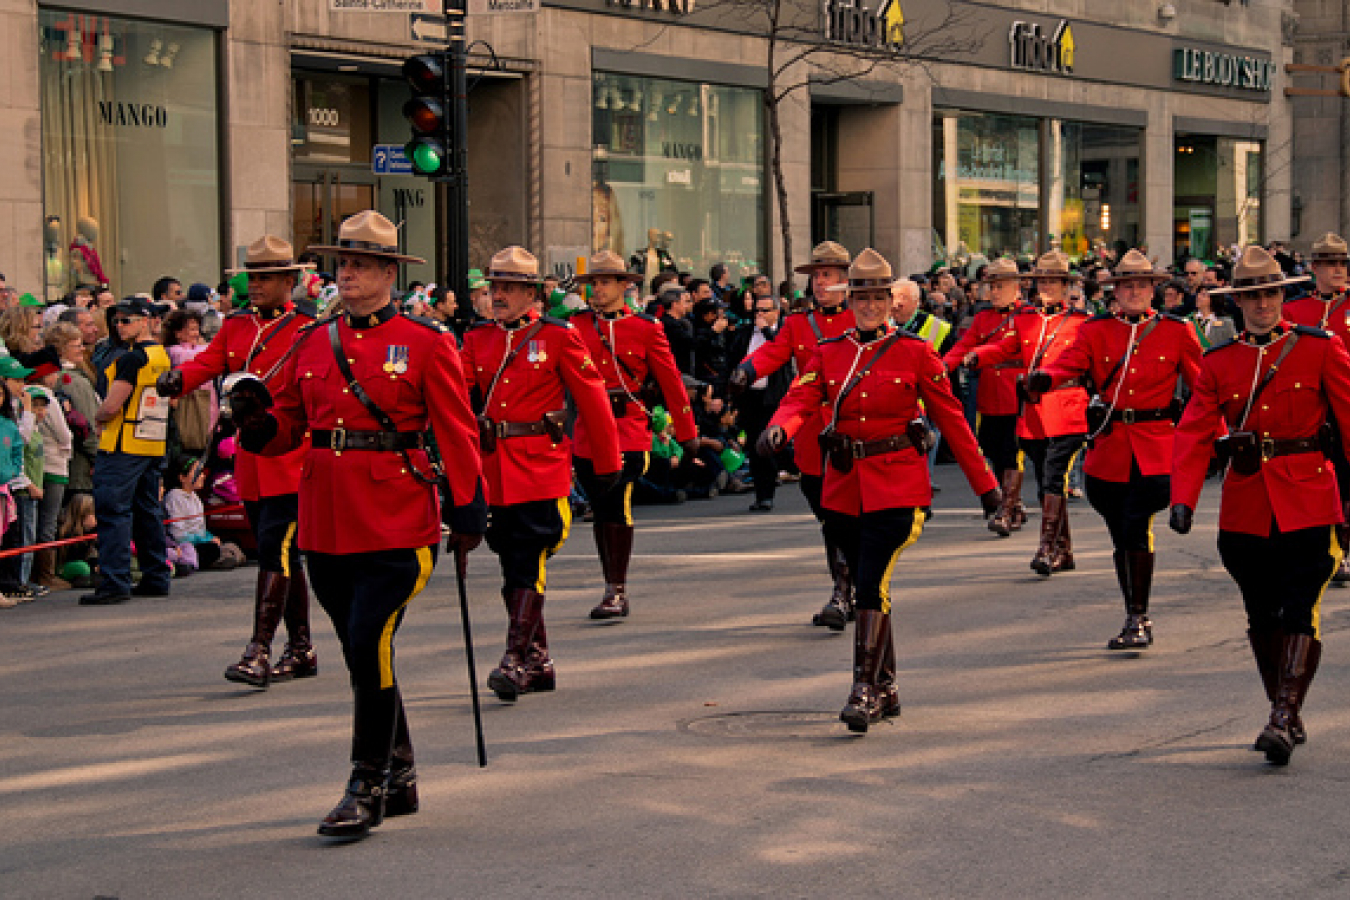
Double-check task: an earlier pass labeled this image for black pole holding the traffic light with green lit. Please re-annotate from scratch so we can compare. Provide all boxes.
[437,0,468,317]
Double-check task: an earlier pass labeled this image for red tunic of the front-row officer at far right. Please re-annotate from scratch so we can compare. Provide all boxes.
[1172,322,1350,537]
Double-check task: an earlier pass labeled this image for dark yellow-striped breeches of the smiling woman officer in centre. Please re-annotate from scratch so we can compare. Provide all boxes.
[824,507,923,613]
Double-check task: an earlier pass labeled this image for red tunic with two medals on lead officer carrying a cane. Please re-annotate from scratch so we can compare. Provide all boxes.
[255,310,483,553]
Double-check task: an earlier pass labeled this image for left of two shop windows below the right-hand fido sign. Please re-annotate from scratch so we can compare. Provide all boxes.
[933,112,1041,259]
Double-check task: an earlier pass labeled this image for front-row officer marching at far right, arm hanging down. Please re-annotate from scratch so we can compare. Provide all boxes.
[1170,247,1350,765]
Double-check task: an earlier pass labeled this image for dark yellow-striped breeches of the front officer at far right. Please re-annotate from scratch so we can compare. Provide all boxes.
[1219,522,1342,640]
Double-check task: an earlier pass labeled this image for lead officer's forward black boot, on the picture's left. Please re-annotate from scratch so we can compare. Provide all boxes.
[319,687,402,838]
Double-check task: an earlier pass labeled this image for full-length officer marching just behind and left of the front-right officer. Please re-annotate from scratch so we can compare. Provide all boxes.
[1026,250,1200,650]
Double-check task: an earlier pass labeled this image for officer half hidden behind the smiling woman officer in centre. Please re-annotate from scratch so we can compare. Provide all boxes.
[729,240,853,631]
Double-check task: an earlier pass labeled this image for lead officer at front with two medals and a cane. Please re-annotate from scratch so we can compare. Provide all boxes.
[230,210,487,838]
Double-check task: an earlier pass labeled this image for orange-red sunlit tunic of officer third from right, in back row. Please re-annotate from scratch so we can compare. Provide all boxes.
[975,306,1088,440]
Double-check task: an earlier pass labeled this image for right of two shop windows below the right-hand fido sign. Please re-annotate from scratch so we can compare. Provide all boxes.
[1046,119,1141,258]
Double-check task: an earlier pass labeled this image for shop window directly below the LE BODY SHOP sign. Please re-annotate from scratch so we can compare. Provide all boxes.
[1172,132,1265,260]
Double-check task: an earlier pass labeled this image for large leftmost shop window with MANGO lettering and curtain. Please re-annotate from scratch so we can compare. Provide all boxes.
[39,11,220,298]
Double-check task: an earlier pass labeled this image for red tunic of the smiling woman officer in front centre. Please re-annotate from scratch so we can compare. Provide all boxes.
[770,329,998,515]
